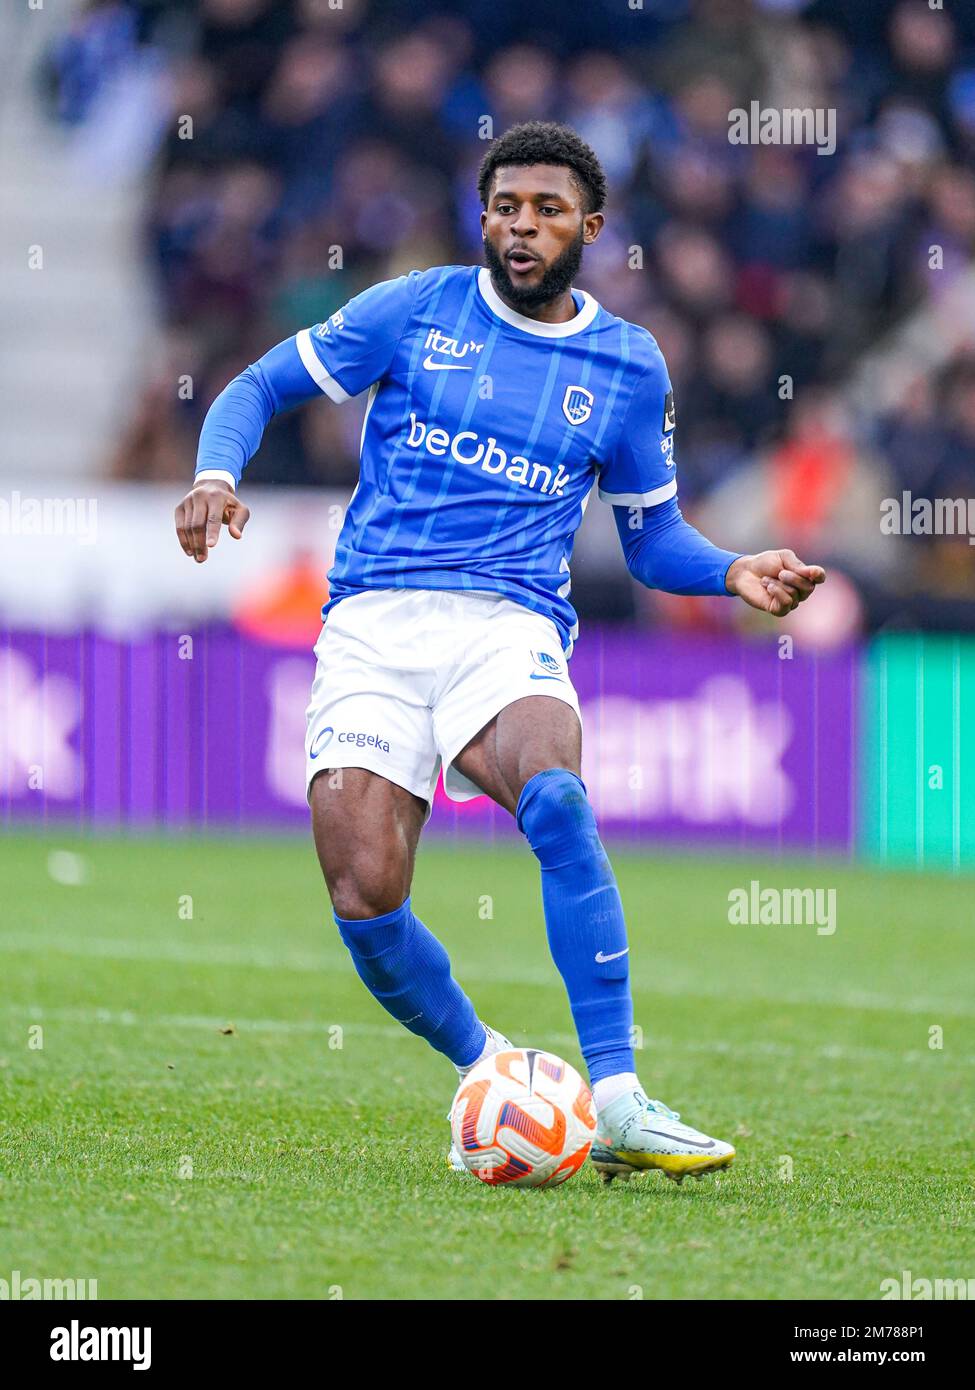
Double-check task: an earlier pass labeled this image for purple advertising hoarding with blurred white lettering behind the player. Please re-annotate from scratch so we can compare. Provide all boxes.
[0,627,858,852]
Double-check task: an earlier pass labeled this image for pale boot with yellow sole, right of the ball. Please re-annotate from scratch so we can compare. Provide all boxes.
[590,1091,734,1183]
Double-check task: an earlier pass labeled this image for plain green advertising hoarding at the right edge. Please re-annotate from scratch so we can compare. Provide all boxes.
[860,632,975,870]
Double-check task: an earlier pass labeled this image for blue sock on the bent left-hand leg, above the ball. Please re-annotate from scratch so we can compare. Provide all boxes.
[334,898,485,1066]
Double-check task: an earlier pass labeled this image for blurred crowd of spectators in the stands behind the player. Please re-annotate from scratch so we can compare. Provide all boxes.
[49,0,975,628]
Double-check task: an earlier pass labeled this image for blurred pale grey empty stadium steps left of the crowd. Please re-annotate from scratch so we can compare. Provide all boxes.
[0,4,157,492]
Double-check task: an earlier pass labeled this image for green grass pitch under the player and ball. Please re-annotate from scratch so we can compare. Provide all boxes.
[0,831,975,1300]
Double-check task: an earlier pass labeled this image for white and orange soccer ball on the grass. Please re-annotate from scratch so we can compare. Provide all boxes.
[451,1048,595,1187]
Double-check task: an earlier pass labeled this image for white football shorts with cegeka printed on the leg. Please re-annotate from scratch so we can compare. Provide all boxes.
[305,589,583,816]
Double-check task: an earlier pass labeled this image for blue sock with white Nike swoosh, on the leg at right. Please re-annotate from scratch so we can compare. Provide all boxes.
[515,767,636,1084]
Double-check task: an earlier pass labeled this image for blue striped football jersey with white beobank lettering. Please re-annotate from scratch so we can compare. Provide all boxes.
[295,265,677,652]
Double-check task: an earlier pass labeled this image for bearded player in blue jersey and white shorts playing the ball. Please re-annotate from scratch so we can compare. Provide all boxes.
[177,121,825,1180]
